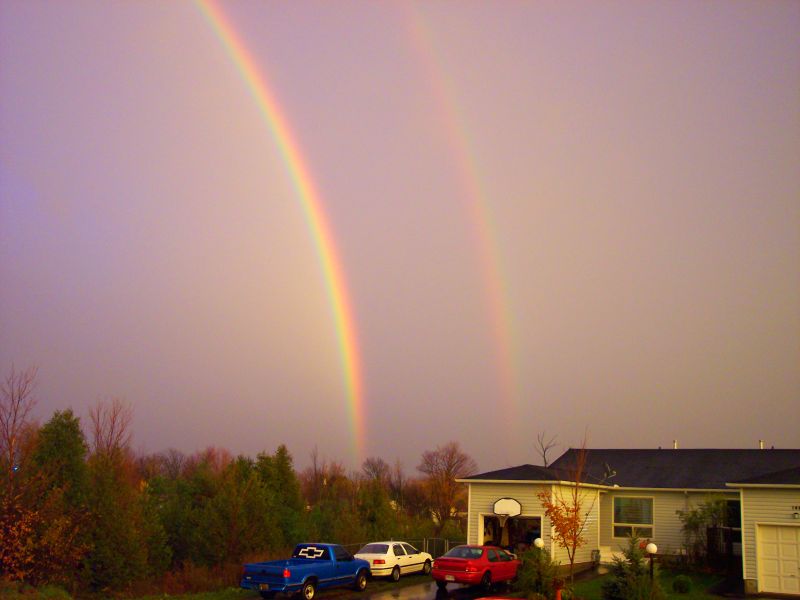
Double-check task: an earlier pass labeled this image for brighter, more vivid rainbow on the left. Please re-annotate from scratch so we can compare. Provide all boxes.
[195,0,366,462]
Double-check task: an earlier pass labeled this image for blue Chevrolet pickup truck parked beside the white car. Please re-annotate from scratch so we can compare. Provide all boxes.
[239,543,369,600]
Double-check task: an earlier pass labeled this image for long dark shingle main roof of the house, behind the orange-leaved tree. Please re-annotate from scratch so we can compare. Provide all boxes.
[552,449,800,489]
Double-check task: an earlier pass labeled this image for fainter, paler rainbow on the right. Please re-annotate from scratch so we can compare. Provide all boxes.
[406,8,521,433]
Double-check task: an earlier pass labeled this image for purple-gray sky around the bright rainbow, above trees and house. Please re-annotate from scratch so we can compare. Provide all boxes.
[0,0,800,471]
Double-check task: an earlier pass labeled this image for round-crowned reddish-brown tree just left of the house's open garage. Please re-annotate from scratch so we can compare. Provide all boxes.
[417,442,478,535]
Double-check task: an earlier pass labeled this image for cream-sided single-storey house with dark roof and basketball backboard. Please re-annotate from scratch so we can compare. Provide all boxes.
[458,449,800,595]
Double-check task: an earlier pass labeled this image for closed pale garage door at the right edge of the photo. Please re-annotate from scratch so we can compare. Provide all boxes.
[758,525,800,594]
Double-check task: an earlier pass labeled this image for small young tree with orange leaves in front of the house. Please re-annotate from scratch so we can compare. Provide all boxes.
[537,439,597,583]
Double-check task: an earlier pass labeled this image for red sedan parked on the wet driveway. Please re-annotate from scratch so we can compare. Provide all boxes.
[431,546,520,591]
